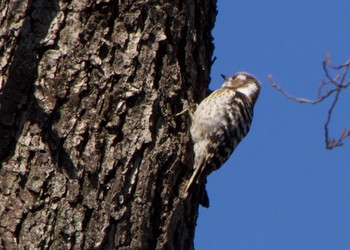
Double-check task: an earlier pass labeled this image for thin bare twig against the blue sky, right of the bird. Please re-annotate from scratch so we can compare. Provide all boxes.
[269,54,350,149]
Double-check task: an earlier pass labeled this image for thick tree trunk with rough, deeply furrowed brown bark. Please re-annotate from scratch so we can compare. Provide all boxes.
[0,0,216,249]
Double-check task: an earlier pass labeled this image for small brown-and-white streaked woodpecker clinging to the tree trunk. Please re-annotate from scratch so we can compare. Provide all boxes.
[184,72,261,198]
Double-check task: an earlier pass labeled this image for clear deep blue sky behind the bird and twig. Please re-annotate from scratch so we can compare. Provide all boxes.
[195,0,350,250]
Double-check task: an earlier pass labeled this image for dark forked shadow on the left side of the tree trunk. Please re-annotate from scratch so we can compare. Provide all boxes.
[0,0,77,178]
